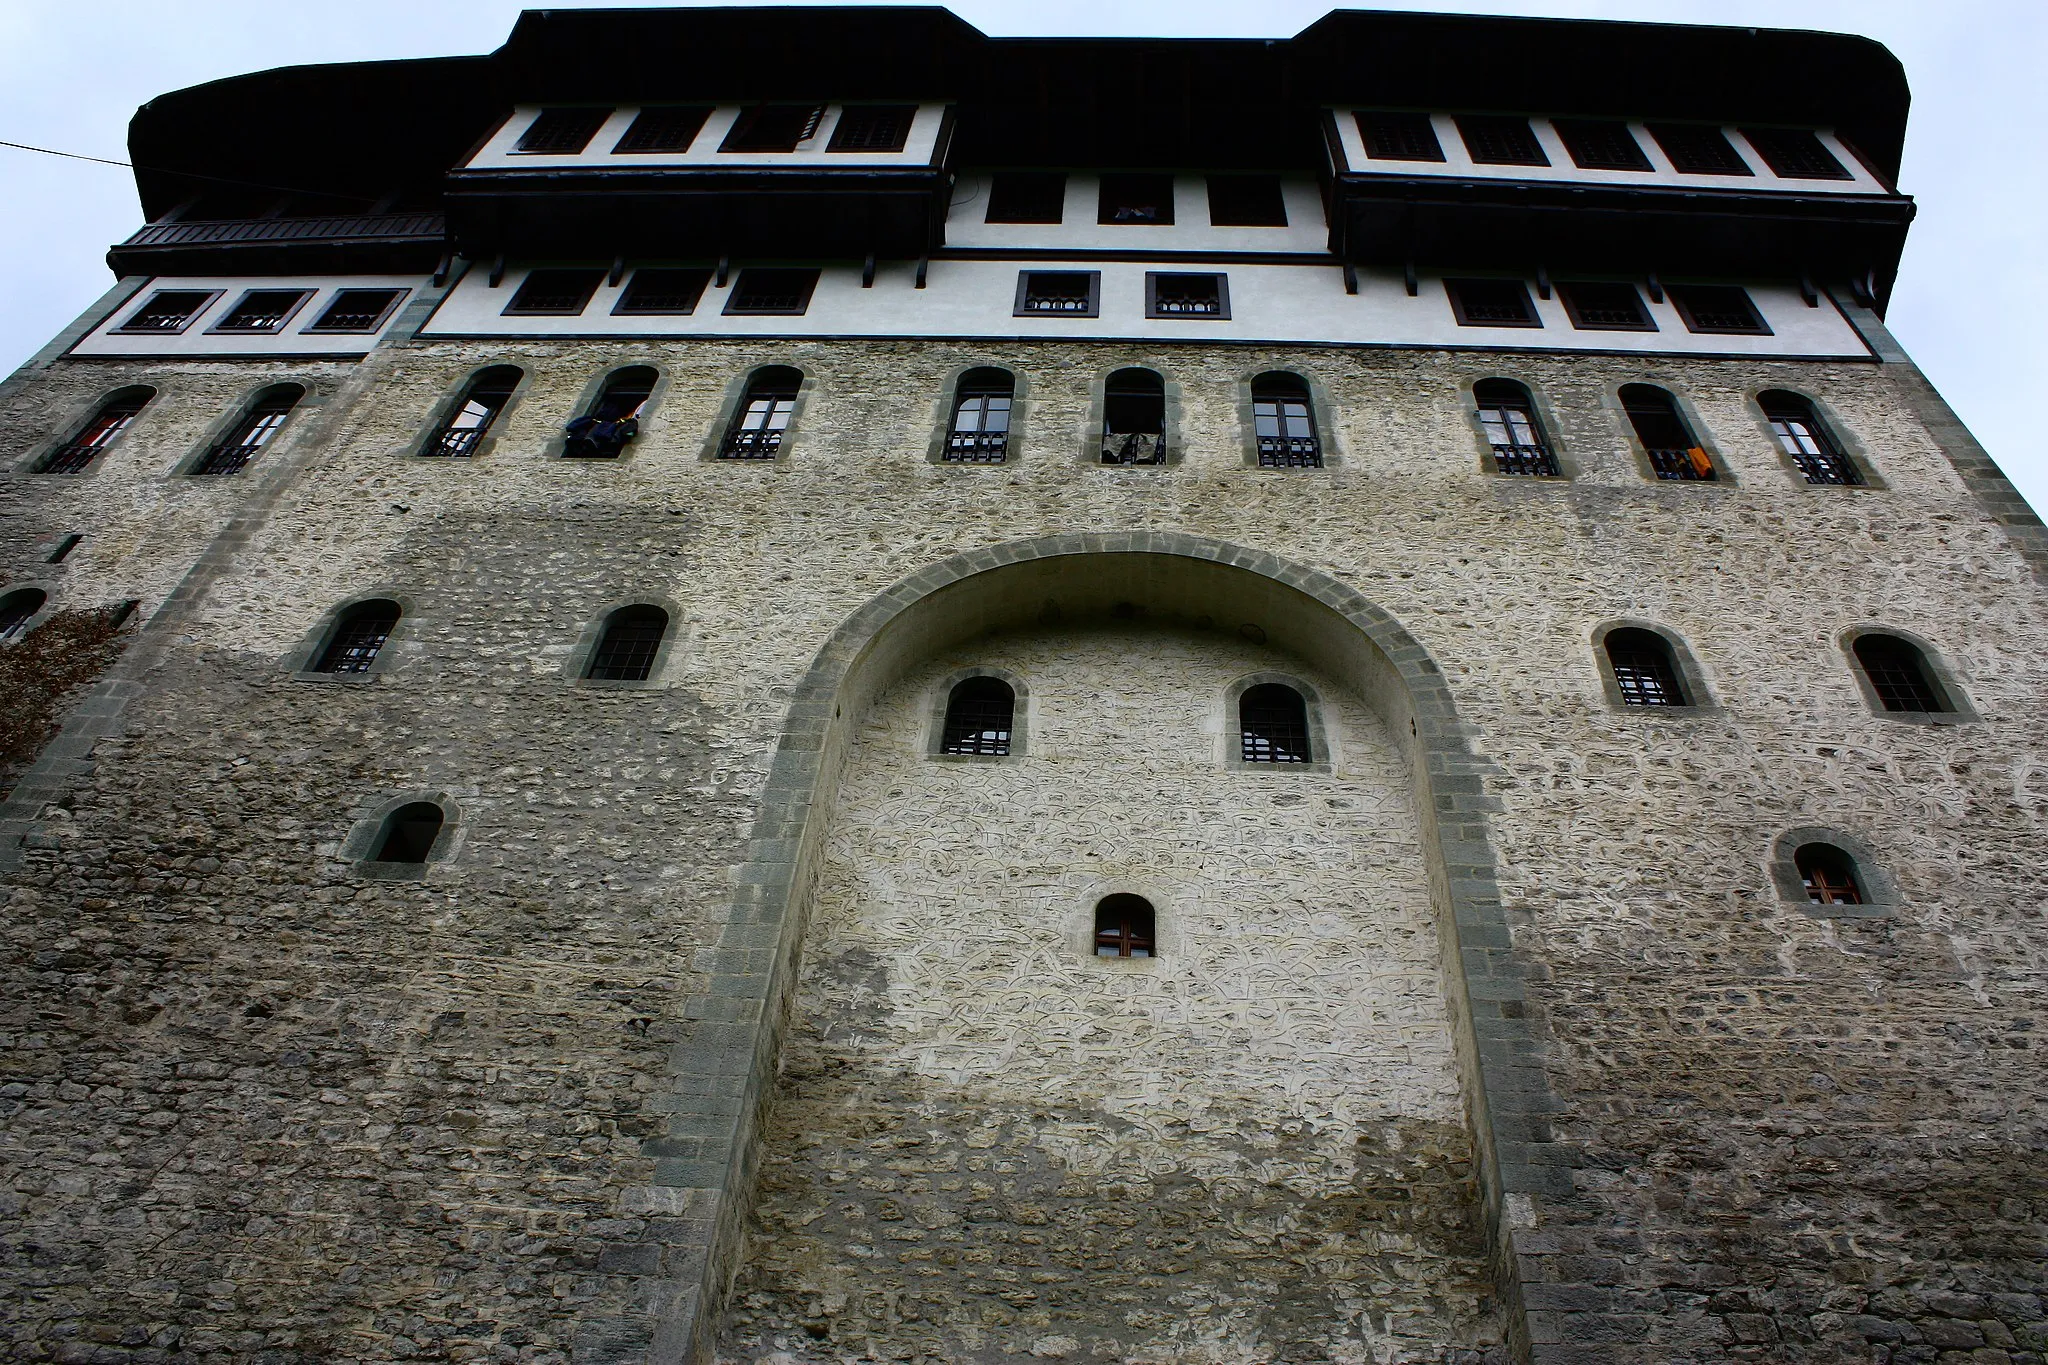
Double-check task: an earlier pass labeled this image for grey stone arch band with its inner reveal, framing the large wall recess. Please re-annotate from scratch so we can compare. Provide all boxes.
[635,532,1571,1361]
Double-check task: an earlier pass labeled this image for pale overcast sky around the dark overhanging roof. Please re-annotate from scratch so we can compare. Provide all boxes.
[0,0,2048,510]
